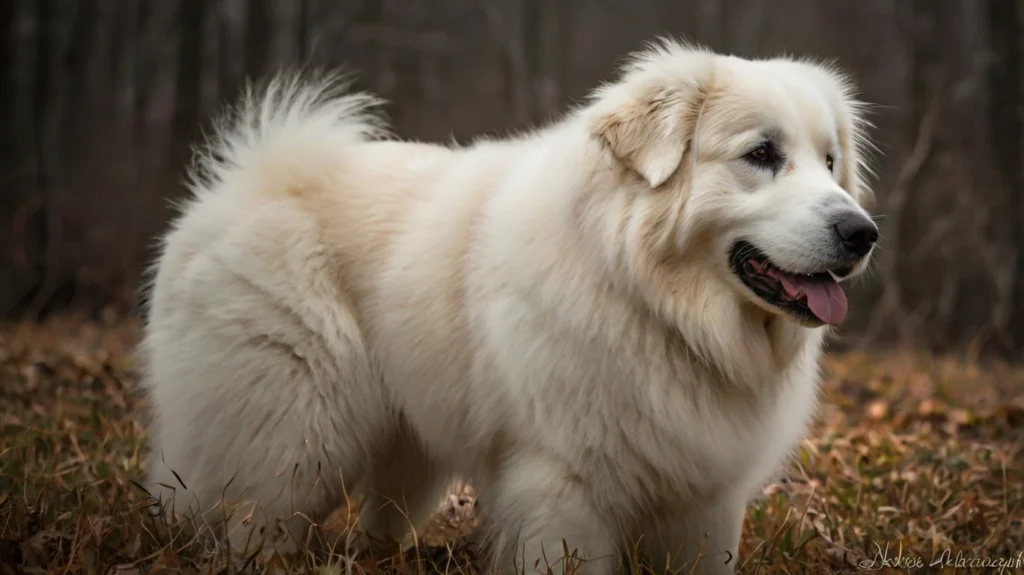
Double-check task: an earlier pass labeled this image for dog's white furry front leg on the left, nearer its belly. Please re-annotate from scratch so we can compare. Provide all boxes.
[478,455,620,575]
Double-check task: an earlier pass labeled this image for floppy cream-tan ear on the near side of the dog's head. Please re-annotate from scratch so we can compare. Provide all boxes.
[591,86,703,188]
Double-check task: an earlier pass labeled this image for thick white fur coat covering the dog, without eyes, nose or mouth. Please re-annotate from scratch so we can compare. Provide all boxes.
[142,41,870,573]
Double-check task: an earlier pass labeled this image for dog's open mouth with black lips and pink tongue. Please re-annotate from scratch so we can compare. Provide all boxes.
[729,241,852,325]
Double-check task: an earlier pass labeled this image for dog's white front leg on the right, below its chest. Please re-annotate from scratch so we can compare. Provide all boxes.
[645,494,746,575]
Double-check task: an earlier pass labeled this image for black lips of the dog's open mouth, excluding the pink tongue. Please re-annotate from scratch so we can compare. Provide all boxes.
[729,240,854,326]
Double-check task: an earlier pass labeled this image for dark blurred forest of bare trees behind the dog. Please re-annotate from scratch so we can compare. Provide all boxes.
[0,0,1024,354]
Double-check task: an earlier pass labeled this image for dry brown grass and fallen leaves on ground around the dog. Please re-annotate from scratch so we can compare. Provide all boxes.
[0,318,1024,574]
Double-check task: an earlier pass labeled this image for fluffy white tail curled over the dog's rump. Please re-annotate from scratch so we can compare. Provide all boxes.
[187,71,388,200]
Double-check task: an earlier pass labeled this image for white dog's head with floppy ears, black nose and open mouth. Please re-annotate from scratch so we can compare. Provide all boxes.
[589,43,878,326]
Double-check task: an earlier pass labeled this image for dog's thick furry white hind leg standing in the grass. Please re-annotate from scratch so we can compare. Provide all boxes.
[145,291,391,554]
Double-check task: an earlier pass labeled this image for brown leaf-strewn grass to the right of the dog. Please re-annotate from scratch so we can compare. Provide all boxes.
[740,353,1024,573]
